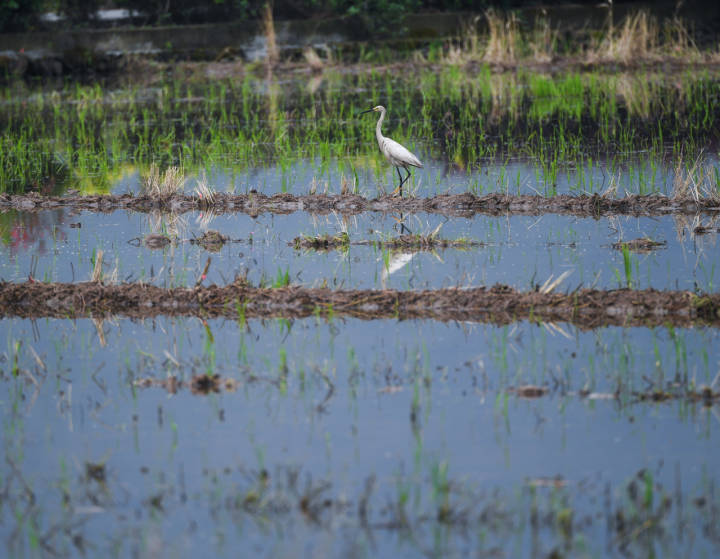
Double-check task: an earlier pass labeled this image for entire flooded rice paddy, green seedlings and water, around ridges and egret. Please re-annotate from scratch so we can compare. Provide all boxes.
[0,67,720,557]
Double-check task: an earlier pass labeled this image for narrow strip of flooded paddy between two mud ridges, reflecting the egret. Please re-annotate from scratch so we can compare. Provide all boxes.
[0,209,720,292]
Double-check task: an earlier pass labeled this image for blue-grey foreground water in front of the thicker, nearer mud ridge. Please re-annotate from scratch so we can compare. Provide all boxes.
[0,312,720,557]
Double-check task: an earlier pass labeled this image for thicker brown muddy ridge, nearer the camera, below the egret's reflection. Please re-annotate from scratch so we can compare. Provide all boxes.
[0,280,720,329]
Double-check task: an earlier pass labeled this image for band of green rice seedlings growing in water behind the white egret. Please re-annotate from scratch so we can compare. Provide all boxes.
[0,65,718,195]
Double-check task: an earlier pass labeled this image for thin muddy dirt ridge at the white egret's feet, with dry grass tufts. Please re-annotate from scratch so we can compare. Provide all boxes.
[0,193,720,217]
